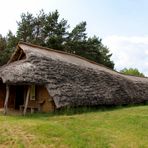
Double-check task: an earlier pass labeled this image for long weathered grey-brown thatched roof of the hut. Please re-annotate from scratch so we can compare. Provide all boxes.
[0,43,148,108]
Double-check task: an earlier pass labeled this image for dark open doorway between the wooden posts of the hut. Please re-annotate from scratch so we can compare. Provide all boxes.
[15,86,25,109]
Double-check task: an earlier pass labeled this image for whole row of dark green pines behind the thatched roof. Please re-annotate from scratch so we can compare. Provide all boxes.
[0,10,114,69]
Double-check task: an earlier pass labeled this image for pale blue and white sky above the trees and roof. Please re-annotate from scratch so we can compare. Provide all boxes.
[0,0,148,76]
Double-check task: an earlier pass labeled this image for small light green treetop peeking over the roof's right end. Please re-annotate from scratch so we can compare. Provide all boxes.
[120,68,145,77]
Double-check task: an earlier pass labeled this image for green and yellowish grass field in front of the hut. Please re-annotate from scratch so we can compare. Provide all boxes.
[0,105,148,148]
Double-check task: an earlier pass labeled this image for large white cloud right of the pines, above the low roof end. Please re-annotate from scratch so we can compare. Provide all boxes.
[103,35,148,76]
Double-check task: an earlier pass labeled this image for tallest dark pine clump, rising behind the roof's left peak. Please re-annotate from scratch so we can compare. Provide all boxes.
[17,10,69,50]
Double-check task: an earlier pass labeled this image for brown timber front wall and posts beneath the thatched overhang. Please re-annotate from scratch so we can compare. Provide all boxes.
[4,85,55,115]
